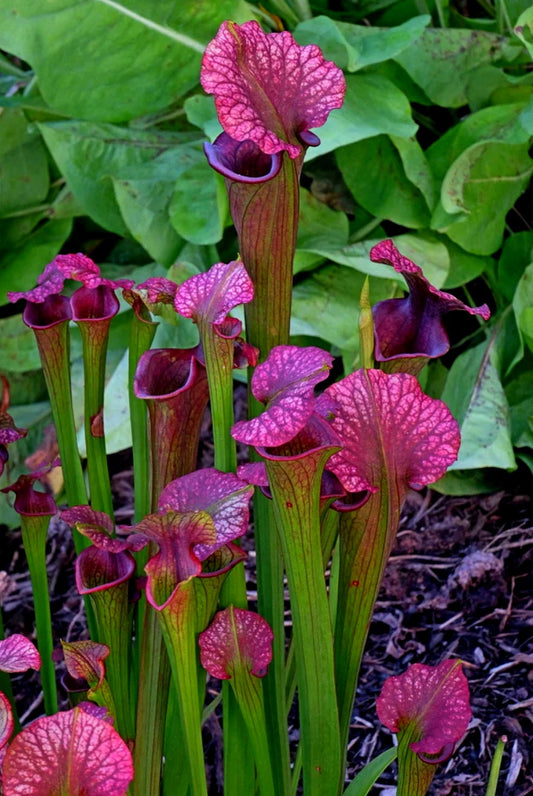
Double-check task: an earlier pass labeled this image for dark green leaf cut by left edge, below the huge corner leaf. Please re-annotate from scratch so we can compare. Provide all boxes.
[0,108,49,216]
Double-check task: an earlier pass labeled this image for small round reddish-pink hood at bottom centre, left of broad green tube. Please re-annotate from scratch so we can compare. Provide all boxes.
[198,606,274,680]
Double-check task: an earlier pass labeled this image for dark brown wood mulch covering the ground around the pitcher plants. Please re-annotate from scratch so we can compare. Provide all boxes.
[0,443,533,796]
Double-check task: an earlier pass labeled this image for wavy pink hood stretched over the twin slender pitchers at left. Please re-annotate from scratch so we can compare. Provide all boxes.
[8,253,134,304]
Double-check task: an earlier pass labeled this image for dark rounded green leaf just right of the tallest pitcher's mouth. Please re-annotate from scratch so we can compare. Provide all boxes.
[337,135,432,229]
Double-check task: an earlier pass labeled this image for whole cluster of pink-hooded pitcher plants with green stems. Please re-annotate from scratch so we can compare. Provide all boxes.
[0,17,502,796]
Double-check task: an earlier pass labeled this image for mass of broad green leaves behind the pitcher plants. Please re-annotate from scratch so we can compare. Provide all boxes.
[0,0,533,521]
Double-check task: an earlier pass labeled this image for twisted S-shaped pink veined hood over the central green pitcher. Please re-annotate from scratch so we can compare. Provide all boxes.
[231,345,333,447]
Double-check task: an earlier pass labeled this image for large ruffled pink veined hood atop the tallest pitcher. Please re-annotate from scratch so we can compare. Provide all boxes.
[200,21,346,158]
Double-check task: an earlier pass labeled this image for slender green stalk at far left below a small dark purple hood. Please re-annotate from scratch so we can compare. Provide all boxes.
[20,514,58,716]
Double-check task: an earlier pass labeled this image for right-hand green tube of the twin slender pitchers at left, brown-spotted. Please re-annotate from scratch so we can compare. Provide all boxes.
[78,320,113,517]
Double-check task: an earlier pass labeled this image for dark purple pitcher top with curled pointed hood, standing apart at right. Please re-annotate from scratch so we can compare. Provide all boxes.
[370,240,490,375]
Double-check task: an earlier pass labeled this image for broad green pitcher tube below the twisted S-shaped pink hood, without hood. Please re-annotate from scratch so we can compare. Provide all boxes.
[266,447,341,796]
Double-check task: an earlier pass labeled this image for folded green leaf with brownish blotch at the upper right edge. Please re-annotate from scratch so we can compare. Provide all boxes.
[431,141,533,254]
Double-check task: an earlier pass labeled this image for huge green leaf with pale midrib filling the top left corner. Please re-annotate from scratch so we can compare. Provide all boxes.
[0,0,250,122]
